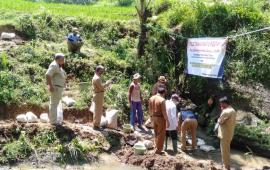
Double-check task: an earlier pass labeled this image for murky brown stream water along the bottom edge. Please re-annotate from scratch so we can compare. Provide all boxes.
[3,150,270,170]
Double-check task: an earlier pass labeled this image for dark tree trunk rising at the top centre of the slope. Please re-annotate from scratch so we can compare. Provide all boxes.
[135,0,151,57]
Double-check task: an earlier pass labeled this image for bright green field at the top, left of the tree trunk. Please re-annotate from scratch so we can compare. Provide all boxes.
[0,0,136,20]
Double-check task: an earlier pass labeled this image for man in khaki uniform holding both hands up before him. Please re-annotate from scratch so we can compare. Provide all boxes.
[90,66,111,130]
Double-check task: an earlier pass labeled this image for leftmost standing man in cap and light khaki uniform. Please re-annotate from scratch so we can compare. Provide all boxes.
[46,53,66,125]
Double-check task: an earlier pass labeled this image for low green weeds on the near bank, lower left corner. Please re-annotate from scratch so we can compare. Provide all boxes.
[0,127,101,165]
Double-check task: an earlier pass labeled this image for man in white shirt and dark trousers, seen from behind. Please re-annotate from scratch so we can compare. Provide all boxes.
[164,94,180,153]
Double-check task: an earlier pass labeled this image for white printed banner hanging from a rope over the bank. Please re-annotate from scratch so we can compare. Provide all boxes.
[187,38,227,78]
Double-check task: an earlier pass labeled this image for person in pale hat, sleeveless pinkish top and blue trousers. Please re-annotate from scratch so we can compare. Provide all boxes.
[128,73,143,128]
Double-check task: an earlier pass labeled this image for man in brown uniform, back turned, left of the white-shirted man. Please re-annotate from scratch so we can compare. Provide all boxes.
[149,88,170,154]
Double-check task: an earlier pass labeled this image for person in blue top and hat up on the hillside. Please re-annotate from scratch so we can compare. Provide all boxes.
[67,28,83,53]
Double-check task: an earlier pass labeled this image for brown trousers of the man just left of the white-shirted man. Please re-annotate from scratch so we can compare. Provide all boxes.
[152,117,166,152]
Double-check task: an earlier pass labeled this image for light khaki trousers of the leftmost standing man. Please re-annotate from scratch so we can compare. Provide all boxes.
[49,86,64,124]
